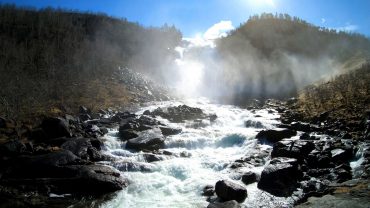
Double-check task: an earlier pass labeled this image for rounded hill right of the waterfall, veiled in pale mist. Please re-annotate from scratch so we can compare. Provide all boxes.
[217,14,370,103]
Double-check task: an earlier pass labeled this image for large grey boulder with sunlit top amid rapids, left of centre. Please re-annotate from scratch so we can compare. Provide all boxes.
[126,128,164,151]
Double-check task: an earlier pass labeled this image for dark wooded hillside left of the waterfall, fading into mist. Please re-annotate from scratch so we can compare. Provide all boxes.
[0,5,181,116]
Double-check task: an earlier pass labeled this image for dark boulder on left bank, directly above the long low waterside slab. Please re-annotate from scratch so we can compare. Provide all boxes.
[61,138,101,161]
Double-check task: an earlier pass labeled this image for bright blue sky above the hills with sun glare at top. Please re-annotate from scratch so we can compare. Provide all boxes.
[0,0,370,37]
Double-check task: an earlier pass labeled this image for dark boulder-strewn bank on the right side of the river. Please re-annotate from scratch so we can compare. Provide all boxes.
[203,99,370,208]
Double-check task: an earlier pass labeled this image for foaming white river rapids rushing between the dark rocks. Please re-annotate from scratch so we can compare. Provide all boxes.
[98,99,292,208]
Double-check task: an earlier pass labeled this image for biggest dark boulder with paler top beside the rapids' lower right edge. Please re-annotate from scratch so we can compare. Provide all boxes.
[257,157,301,197]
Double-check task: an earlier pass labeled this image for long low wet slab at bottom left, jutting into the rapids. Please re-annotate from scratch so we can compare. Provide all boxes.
[2,165,127,195]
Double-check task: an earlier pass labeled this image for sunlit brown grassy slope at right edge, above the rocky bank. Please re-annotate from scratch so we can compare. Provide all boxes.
[297,63,370,120]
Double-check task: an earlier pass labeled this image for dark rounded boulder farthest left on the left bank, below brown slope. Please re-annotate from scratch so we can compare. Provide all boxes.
[41,117,72,139]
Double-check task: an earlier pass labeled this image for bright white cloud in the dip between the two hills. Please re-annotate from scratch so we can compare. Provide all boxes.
[184,20,235,47]
